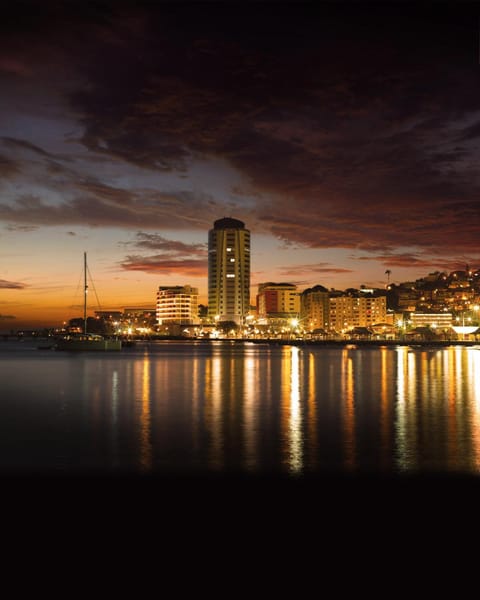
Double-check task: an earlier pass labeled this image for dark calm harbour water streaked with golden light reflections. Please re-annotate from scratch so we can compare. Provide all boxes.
[0,341,480,476]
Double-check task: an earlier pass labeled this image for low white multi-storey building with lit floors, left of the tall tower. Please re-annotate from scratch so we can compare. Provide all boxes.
[156,285,198,325]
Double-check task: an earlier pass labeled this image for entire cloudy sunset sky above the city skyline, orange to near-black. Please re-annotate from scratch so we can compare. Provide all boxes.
[0,0,480,330]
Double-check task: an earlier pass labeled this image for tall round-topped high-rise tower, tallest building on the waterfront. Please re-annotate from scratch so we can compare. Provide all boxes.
[208,217,250,325]
